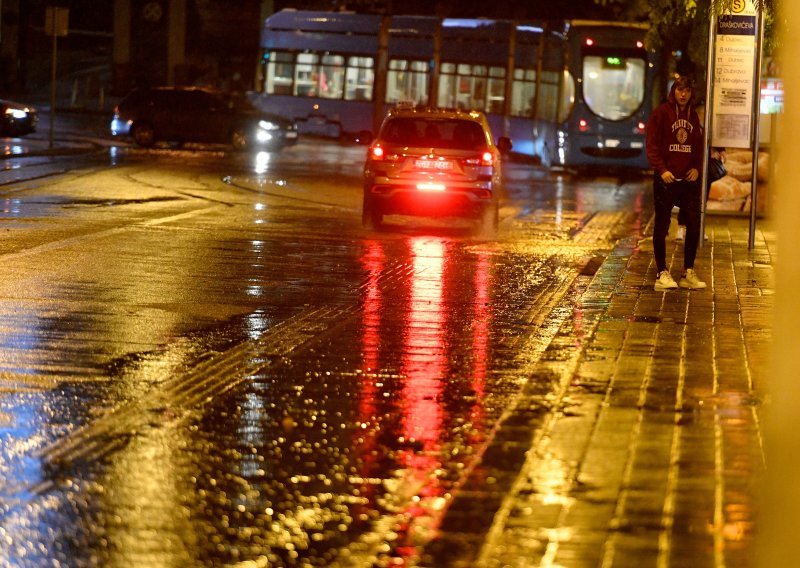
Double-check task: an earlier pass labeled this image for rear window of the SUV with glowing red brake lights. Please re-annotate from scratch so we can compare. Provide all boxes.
[381,117,486,150]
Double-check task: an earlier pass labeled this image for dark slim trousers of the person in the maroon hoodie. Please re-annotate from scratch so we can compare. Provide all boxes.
[653,176,700,272]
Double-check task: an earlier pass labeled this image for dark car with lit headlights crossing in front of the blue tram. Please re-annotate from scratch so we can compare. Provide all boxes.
[111,87,297,150]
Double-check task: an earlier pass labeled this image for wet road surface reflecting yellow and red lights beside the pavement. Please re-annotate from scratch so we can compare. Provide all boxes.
[0,141,648,567]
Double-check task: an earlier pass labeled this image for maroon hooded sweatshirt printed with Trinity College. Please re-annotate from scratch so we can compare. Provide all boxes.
[646,84,703,179]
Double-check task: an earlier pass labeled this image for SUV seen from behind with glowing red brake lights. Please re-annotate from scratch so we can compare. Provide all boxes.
[362,106,511,232]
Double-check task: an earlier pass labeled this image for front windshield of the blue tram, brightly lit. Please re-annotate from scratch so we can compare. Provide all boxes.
[583,51,647,120]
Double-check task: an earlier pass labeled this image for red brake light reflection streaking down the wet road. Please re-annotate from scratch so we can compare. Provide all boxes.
[358,236,493,561]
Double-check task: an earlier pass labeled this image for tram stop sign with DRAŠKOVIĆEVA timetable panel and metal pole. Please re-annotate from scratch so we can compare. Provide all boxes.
[701,0,764,248]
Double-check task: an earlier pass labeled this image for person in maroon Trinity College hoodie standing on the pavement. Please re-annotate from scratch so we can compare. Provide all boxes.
[647,76,706,292]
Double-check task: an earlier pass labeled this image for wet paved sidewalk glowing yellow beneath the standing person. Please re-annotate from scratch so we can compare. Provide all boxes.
[437,216,775,568]
